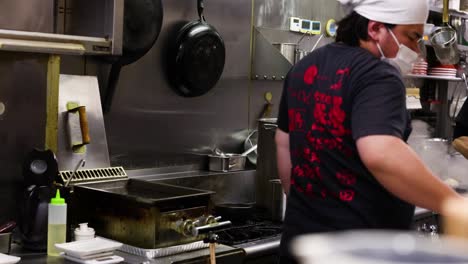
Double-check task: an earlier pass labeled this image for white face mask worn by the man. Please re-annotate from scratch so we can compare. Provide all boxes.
[377,29,419,75]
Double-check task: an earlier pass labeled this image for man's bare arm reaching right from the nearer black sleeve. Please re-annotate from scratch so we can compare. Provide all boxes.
[357,135,462,212]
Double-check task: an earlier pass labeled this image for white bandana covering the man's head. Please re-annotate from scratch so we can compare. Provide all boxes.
[338,0,429,25]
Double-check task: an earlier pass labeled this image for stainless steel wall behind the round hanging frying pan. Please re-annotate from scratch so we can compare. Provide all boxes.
[96,0,340,168]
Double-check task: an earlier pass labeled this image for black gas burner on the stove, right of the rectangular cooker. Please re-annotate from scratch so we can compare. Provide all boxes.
[217,220,283,246]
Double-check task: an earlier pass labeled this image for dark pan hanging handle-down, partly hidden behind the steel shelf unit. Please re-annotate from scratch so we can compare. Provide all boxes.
[103,0,163,113]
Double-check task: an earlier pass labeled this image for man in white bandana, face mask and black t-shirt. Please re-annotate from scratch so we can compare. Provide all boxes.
[275,0,463,263]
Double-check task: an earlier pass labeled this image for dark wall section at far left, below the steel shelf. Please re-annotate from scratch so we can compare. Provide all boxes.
[0,53,47,223]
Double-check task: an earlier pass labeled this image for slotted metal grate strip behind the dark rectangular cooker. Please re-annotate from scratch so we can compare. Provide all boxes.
[59,167,127,184]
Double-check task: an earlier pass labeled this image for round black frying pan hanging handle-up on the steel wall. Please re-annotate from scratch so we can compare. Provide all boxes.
[169,0,226,97]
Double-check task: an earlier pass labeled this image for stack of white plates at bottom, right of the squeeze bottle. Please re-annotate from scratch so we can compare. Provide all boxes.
[55,237,124,264]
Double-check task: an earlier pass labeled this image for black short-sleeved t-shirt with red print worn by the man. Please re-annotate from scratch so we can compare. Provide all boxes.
[278,43,414,254]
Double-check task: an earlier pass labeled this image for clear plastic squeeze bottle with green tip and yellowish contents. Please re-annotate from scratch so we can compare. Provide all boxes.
[47,190,67,256]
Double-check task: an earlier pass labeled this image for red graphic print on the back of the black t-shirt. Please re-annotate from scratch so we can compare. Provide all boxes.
[288,65,357,202]
